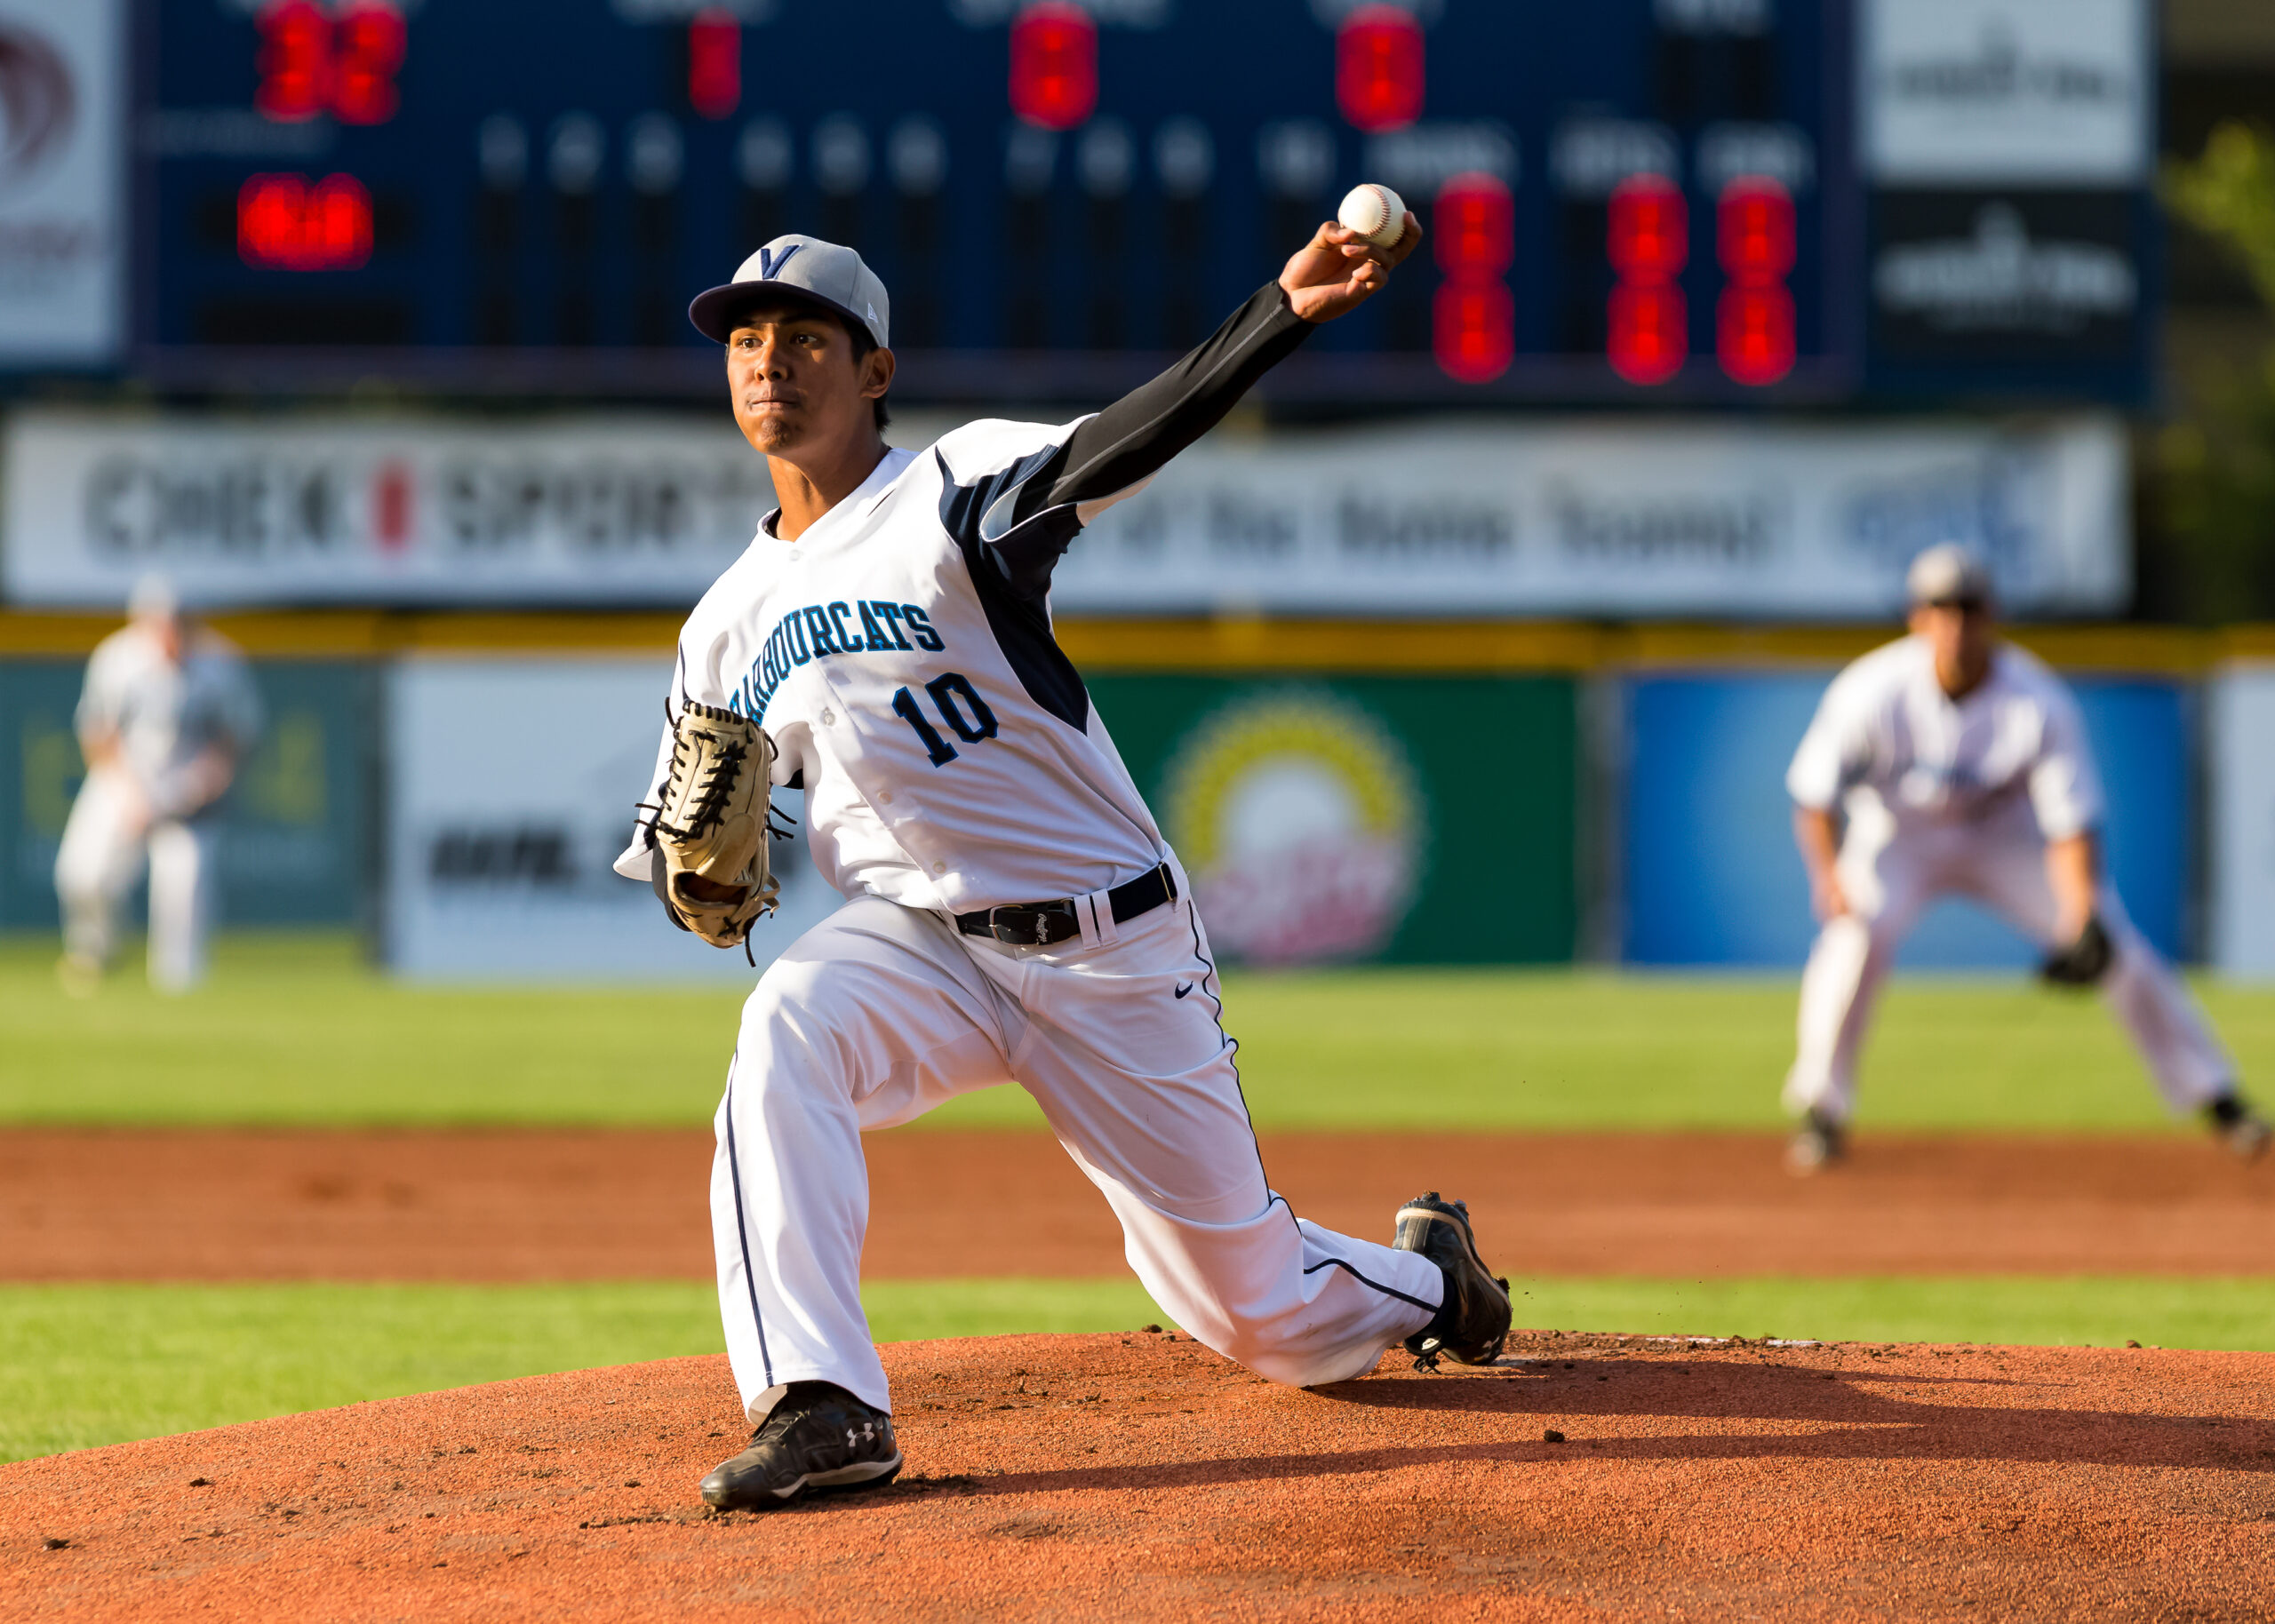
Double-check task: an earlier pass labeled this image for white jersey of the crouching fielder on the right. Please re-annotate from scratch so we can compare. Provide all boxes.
[1786,637,2102,840]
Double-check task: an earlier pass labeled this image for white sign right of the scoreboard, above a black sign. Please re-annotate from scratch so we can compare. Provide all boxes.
[1856,0,2152,187]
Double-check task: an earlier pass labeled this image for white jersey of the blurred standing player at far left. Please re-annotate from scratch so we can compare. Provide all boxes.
[77,625,261,796]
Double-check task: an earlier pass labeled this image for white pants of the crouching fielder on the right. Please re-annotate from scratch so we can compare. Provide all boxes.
[1786,808,2236,1121]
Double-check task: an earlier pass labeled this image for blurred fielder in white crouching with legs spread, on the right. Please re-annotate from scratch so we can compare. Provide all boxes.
[1786,545,2268,1174]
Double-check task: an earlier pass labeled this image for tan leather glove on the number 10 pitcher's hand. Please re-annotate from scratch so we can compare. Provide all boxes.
[655,701,780,951]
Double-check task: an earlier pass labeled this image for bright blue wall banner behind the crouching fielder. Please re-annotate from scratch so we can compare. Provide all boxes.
[1622,671,2189,969]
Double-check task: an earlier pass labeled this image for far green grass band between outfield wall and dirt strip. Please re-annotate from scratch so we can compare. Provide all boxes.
[0,935,2275,1130]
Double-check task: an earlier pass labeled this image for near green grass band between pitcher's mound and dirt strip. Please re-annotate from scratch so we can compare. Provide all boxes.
[0,1276,2275,1461]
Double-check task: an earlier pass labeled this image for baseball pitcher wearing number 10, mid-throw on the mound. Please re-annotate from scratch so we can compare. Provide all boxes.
[617,216,1508,1508]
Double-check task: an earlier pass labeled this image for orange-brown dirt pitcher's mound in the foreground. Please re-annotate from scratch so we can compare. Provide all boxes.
[0,1333,2275,1621]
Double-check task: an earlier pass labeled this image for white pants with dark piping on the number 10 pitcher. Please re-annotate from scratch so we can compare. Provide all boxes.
[712,878,1445,1424]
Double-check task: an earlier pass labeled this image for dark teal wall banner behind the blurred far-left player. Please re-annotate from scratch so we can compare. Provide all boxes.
[0,659,375,930]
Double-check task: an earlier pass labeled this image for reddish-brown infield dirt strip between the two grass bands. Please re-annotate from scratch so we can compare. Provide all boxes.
[0,1128,2275,1280]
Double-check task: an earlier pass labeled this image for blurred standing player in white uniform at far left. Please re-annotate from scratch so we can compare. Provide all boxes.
[54,580,261,994]
